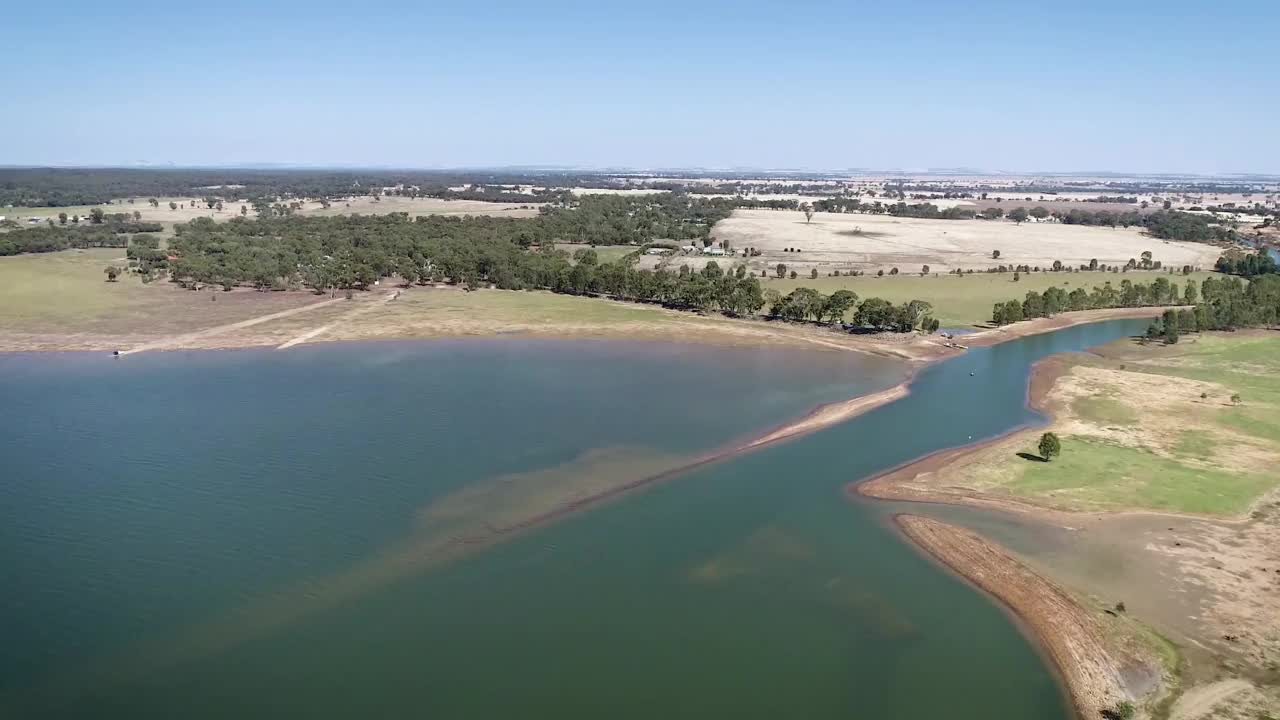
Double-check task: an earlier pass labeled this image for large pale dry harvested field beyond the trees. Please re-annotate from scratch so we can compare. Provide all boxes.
[714,210,1220,275]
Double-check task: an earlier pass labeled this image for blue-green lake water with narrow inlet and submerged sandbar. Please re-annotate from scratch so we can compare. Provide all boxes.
[0,320,1146,720]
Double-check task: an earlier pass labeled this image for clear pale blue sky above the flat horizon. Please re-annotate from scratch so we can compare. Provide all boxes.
[10,0,1280,173]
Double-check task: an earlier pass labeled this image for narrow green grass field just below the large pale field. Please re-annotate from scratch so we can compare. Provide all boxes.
[762,273,1213,327]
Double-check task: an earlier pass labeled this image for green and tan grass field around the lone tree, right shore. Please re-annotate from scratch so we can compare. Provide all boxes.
[988,331,1280,515]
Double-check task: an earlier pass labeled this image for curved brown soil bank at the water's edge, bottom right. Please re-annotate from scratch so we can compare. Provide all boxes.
[895,515,1129,717]
